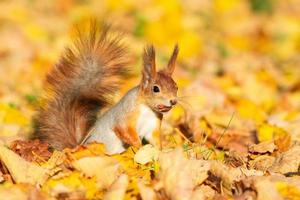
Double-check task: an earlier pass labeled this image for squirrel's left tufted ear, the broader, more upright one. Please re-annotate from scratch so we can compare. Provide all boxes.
[142,45,156,86]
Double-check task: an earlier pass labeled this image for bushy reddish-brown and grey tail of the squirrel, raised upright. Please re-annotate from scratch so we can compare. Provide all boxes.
[35,25,128,149]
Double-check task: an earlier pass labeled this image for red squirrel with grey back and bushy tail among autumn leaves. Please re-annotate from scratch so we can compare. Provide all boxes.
[34,23,179,155]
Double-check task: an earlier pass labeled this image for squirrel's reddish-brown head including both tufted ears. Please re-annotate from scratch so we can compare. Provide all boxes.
[140,45,179,113]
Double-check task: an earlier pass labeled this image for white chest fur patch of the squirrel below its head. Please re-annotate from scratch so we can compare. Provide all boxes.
[136,104,160,142]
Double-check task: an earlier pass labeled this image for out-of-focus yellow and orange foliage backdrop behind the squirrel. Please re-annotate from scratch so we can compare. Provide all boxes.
[0,0,300,148]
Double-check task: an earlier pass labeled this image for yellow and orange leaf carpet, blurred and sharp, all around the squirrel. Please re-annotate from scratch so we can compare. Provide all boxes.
[0,0,300,200]
